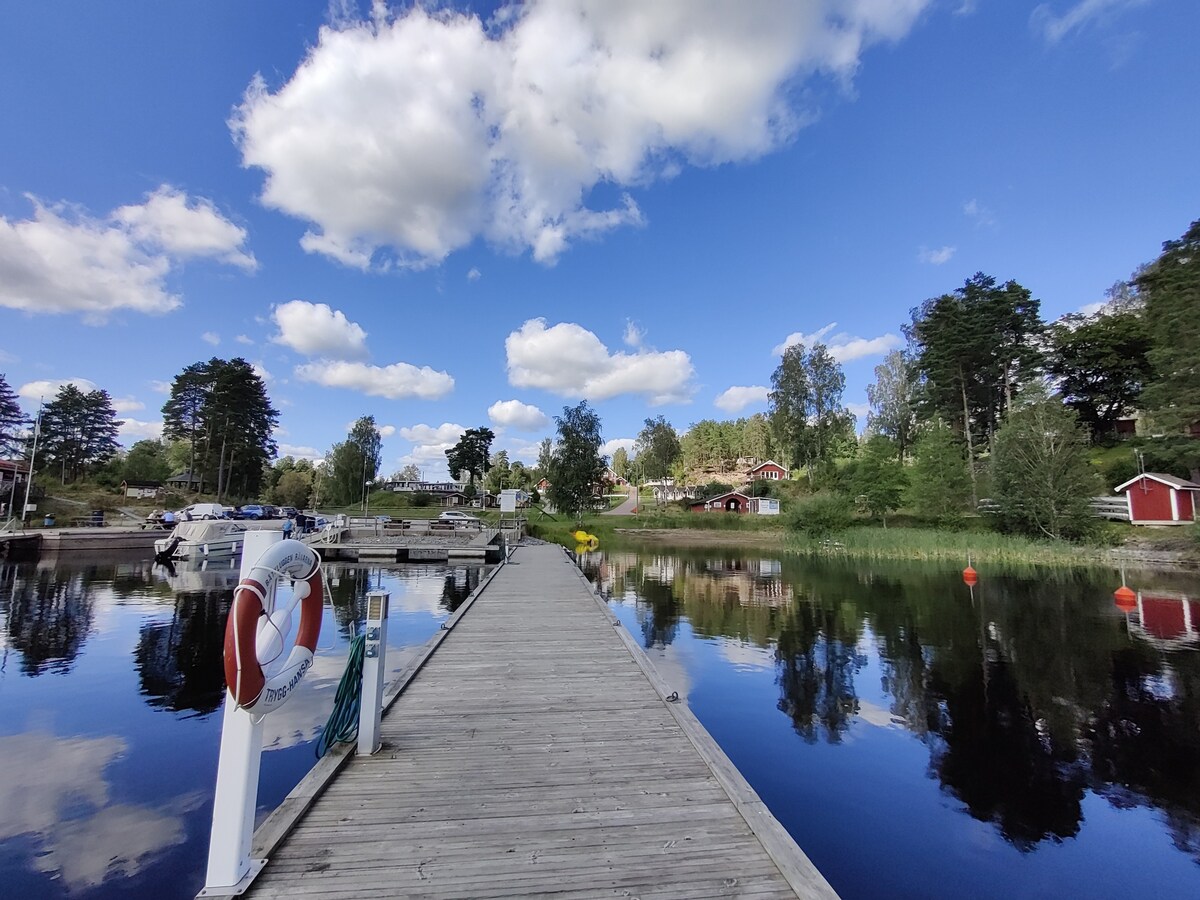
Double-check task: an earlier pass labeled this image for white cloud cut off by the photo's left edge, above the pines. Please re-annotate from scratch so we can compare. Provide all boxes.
[0,186,254,324]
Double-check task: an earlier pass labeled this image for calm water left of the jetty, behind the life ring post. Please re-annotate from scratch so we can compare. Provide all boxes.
[0,557,481,900]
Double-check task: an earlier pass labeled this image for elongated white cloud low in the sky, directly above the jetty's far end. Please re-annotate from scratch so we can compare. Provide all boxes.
[504,319,695,406]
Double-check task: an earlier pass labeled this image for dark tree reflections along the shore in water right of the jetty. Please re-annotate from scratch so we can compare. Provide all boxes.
[584,551,1200,862]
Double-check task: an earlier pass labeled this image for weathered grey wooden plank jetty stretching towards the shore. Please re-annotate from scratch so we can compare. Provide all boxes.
[250,546,835,899]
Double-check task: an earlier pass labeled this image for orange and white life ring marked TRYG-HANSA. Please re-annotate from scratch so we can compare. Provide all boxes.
[224,540,324,715]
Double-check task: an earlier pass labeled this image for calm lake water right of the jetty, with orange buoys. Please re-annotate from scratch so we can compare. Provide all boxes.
[582,551,1200,899]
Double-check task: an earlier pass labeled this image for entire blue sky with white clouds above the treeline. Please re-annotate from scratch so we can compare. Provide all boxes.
[0,0,1200,478]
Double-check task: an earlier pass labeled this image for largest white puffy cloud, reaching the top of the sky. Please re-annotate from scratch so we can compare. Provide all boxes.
[229,0,932,269]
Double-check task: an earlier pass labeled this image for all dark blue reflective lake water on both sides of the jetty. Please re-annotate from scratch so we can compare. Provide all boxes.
[0,551,1200,900]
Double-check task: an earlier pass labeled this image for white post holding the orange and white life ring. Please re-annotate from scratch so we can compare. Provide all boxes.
[204,530,283,896]
